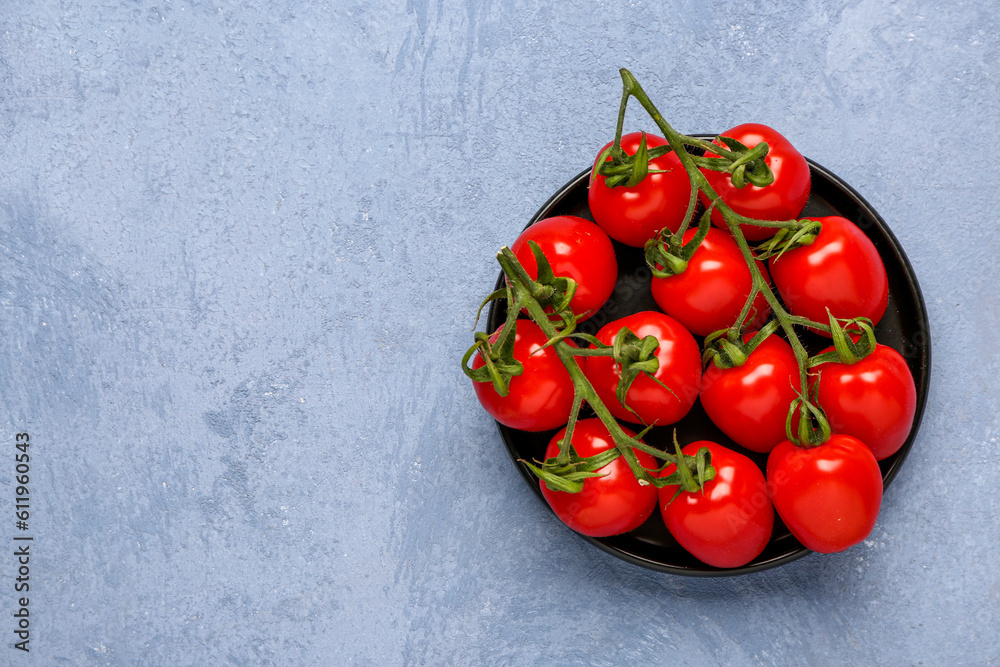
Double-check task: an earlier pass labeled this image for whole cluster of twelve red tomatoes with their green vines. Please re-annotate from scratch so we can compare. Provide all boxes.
[463,70,916,568]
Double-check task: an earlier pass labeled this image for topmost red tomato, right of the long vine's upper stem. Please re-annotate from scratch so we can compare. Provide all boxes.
[700,123,810,241]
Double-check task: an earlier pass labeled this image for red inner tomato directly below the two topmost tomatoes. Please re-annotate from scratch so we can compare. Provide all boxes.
[652,229,771,336]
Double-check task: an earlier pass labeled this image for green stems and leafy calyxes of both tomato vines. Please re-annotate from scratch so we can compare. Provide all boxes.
[463,69,888,491]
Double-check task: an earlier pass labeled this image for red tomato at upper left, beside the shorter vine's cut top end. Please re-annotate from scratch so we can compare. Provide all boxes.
[510,215,618,321]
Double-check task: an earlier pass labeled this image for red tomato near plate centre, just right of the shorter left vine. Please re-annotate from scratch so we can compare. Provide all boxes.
[584,311,701,426]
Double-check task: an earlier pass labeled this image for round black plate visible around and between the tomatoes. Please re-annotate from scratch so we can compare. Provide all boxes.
[487,154,931,577]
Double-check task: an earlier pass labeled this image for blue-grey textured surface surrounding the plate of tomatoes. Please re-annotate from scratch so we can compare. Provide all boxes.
[0,0,1000,665]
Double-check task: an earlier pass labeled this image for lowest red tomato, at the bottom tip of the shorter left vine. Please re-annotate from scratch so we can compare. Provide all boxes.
[660,440,774,567]
